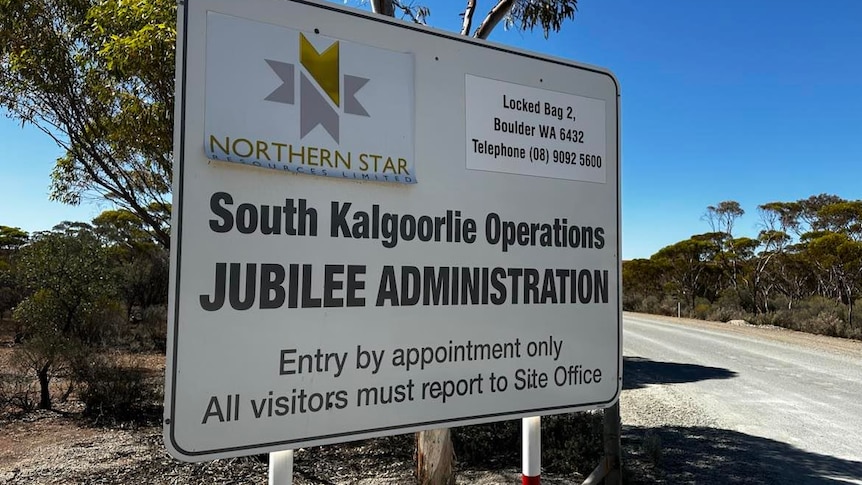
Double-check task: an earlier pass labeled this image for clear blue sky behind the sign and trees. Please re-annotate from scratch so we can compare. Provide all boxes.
[0,0,862,259]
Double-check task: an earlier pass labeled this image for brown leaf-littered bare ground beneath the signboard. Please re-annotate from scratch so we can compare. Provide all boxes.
[0,411,580,485]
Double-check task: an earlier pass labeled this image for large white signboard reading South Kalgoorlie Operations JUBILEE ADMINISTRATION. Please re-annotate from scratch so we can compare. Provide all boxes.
[164,0,621,460]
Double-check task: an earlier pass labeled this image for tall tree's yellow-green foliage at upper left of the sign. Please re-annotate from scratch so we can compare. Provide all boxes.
[0,0,176,246]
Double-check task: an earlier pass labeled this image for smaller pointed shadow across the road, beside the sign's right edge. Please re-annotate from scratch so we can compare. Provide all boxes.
[623,357,736,389]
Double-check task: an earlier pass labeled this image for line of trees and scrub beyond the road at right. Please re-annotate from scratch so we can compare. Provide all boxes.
[623,194,862,339]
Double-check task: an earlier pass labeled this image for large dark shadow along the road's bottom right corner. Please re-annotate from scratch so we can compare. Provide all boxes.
[622,426,862,485]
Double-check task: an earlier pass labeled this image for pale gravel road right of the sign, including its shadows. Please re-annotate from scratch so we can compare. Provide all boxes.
[621,314,862,484]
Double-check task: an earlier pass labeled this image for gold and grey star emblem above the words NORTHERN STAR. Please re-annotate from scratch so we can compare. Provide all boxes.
[265,33,370,143]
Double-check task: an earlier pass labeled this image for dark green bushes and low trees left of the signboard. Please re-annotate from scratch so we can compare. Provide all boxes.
[0,210,169,416]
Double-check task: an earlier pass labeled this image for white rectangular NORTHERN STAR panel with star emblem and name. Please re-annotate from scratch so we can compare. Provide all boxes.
[204,13,416,184]
